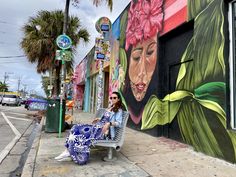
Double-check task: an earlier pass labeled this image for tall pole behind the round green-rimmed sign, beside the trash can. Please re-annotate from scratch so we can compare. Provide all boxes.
[58,0,70,138]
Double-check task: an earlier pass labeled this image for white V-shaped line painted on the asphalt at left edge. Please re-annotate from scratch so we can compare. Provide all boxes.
[0,112,21,164]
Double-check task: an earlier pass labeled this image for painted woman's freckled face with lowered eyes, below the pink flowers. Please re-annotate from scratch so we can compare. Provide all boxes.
[129,37,157,101]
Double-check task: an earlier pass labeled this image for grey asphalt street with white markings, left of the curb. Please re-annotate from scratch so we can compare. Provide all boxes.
[0,106,37,177]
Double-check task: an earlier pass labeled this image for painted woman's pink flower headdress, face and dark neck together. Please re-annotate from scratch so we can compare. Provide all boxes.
[120,0,164,124]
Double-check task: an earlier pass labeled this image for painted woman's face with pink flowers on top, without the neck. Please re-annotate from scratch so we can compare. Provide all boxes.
[125,0,163,102]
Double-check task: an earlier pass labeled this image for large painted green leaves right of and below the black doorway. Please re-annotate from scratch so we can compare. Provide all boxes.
[141,0,236,162]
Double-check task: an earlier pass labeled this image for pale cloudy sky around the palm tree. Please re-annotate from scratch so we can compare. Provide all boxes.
[0,0,130,95]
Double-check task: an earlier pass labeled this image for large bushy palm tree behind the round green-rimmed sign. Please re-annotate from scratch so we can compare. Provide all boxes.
[21,10,89,95]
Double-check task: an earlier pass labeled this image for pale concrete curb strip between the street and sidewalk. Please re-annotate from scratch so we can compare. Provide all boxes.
[21,117,45,177]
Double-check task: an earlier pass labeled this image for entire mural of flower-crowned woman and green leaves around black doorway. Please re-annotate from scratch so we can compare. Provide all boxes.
[111,0,236,162]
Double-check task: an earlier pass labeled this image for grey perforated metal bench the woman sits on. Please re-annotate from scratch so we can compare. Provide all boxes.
[94,108,129,161]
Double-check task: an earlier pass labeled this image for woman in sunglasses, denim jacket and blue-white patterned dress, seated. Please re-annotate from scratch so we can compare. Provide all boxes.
[55,92,123,165]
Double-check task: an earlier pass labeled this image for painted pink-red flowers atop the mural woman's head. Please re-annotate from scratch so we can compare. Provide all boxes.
[125,0,164,50]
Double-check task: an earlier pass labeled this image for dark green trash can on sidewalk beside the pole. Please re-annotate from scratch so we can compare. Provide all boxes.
[45,99,66,133]
